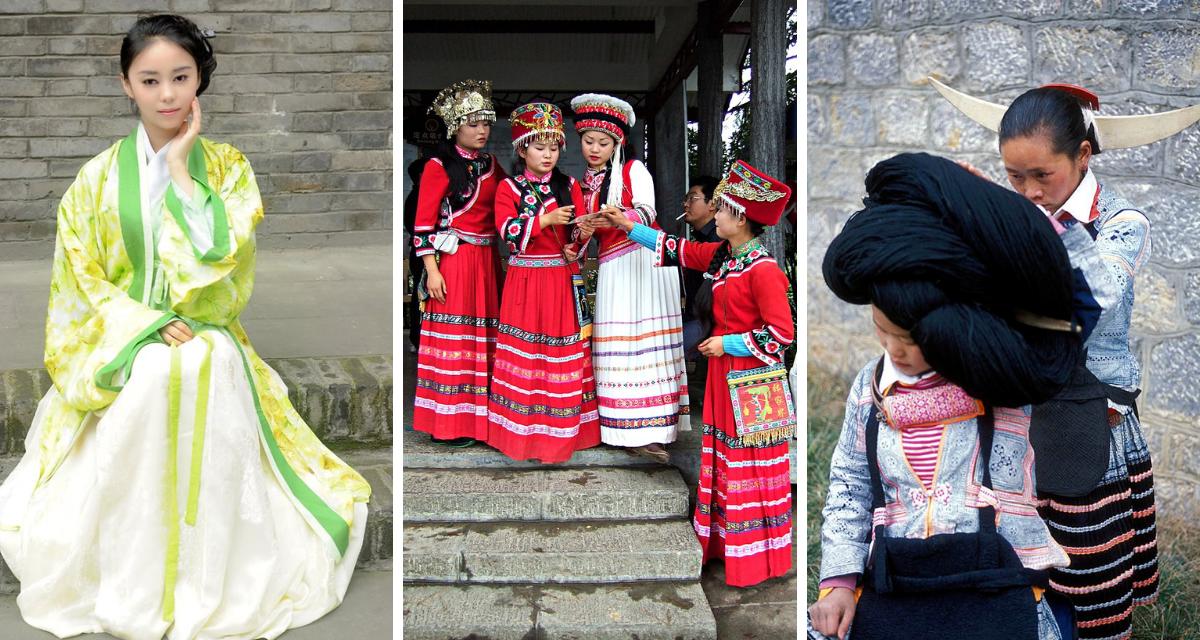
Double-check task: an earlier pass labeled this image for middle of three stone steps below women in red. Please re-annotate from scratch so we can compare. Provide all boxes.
[403,520,702,584]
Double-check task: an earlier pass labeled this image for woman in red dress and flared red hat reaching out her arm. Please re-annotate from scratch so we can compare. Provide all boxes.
[605,161,796,587]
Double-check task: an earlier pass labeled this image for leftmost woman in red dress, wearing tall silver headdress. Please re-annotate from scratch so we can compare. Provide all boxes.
[413,80,504,445]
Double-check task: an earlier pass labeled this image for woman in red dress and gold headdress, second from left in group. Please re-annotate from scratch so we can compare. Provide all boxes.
[487,102,600,462]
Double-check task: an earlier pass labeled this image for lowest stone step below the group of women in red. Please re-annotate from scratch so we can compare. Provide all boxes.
[402,582,716,640]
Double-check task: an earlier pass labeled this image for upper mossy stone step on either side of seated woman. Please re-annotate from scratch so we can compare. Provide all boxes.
[0,355,392,455]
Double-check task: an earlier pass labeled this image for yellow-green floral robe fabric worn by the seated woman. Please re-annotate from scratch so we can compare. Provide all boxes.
[40,133,370,522]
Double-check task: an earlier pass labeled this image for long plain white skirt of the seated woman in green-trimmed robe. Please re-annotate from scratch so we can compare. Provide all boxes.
[0,331,367,640]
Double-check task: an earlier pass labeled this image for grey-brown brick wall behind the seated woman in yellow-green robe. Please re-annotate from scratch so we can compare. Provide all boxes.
[0,0,392,259]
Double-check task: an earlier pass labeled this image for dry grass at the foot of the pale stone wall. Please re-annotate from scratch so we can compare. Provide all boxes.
[805,367,1200,640]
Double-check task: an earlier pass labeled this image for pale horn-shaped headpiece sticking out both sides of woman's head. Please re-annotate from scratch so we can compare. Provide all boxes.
[929,77,1200,149]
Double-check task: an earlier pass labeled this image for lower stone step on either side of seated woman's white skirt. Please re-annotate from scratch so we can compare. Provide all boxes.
[0,447,394,594]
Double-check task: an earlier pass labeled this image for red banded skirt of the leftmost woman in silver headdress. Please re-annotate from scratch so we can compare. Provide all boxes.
[413,243,500,439]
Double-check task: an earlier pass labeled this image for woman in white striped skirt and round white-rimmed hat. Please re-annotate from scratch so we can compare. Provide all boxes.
[571,94,689,463]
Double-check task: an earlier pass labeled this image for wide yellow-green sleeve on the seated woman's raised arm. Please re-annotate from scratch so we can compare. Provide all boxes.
[158,143,263,327]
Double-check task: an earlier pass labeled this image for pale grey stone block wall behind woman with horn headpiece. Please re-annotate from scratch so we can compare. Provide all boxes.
[808,0,1200,515]
